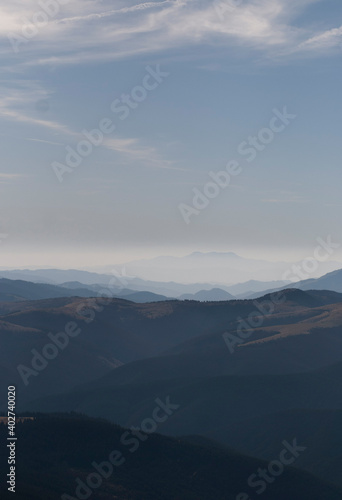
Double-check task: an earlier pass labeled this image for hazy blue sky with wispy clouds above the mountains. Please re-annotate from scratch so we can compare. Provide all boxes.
[0,0,342,268]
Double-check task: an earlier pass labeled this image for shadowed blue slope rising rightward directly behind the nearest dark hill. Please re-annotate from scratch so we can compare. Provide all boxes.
[28,363,342,486]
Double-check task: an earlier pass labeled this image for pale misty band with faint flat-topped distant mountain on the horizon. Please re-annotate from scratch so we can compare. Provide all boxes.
[0,247,342,288]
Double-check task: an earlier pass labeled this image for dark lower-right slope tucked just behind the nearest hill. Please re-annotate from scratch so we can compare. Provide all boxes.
[212,410,342,487]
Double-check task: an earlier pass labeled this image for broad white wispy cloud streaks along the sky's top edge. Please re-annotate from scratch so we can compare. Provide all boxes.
[0,0,341,65]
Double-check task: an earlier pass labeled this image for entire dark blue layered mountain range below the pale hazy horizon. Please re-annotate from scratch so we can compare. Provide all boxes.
[0,271,342,500]
